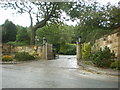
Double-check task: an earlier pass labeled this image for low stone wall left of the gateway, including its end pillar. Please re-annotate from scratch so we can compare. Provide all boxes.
[2,43,54,60]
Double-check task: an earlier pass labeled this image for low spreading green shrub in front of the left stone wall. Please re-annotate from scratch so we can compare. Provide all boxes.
[15,52,35,61]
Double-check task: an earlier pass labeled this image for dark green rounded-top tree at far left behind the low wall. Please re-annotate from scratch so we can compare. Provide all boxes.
[2,20,17,43]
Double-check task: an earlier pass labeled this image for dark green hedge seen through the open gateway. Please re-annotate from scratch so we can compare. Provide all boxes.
[60,44,76,55]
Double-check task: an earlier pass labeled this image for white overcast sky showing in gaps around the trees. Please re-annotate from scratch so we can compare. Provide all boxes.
[0,0,120,27]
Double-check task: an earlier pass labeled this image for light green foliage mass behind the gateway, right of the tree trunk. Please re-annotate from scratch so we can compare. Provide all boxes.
[36,24,74,44]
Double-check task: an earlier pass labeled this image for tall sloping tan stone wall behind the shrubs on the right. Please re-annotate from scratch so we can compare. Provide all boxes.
[92,28,120,59]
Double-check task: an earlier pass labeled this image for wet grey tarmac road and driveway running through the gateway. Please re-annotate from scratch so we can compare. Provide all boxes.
[2,56,118,88]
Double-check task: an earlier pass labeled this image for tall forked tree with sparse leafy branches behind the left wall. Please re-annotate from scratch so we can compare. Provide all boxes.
[2,1,67,44]
